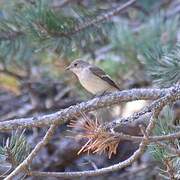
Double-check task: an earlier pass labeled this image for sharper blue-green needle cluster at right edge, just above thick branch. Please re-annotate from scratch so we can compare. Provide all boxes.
[141,44,180,87]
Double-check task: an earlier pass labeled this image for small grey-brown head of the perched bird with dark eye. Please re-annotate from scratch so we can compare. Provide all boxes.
[66,59,89,74]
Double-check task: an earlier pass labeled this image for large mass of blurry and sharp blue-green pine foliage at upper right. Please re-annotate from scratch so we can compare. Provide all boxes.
[111,13,180,86]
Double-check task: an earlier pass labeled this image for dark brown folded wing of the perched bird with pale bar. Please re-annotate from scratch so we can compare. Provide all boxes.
[90,66,120,90]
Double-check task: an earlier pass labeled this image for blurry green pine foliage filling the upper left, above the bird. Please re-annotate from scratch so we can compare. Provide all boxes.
[0,0,112,76]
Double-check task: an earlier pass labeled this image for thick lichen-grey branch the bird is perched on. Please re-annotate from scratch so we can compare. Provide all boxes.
[0,88,169,131]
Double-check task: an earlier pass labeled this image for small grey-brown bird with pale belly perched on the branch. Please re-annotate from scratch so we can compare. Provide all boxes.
[66,59,120,95]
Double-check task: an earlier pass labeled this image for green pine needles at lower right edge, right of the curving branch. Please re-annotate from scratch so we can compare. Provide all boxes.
[148,107,180,178]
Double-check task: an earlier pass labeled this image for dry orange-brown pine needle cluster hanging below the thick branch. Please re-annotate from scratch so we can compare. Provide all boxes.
[69,114,119,158]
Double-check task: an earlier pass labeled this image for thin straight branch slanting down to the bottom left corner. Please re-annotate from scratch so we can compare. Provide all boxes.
[4,125,56,180]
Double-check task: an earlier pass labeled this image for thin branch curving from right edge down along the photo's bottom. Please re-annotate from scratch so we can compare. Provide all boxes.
[17,86,180,177]
